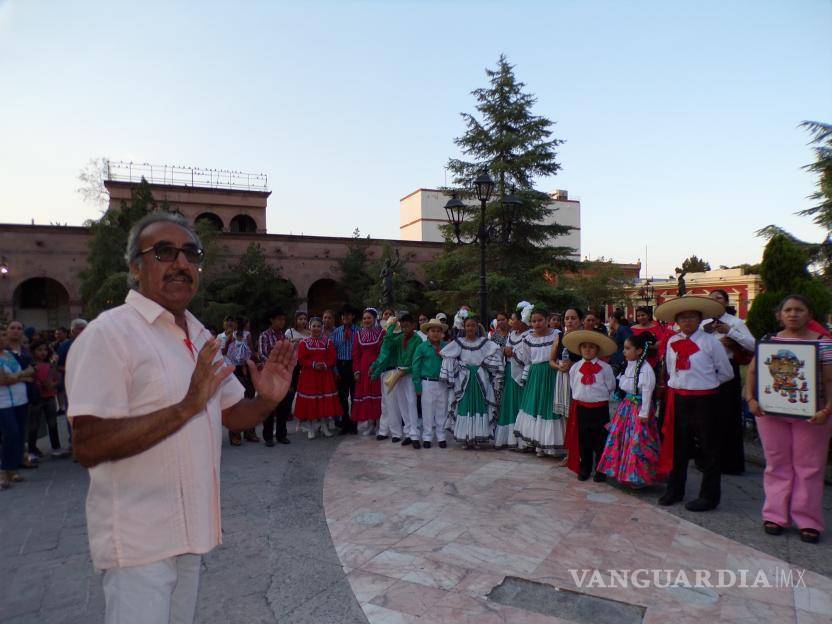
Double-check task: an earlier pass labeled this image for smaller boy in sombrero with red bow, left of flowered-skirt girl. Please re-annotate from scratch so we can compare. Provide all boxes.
[563,329,618,481]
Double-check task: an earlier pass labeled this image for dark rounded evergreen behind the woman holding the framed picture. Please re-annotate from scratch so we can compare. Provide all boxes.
[746,235,832,338]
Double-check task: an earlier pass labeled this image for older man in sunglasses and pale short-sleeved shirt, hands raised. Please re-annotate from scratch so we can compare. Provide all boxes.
[66,213,292,624]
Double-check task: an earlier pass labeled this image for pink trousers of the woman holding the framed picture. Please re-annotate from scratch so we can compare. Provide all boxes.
[757,416,832,531]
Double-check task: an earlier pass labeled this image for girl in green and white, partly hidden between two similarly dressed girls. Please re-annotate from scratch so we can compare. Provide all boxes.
[494,301,533,449]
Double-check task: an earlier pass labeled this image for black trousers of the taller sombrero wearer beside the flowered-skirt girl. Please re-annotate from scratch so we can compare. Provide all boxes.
[667,394,722,505]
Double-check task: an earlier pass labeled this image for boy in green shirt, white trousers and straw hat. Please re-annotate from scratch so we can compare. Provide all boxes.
[412,318,448,448]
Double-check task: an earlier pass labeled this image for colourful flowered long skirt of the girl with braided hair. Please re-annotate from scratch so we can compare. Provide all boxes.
[597,394,659,487]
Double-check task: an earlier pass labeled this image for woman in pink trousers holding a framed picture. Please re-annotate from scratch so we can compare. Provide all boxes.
[745,295,832,544]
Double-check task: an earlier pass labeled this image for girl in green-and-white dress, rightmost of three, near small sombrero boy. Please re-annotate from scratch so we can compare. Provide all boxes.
[514,310,565,455]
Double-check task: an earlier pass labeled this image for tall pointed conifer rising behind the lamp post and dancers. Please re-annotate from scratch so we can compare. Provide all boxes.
[426,55,574,310]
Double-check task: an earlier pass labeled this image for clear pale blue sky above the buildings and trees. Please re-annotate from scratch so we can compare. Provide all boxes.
[0,0,832,276]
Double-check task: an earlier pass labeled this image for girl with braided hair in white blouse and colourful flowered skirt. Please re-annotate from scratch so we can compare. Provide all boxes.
[597,332,659,488]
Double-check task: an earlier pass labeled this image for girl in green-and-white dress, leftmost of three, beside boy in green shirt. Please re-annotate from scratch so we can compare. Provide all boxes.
[439,316,504,448]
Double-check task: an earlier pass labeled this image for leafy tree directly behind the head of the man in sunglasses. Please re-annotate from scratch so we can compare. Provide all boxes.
[80,178,161,318]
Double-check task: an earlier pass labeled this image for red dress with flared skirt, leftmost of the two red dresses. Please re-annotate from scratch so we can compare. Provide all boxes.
[295,336,342,420]
